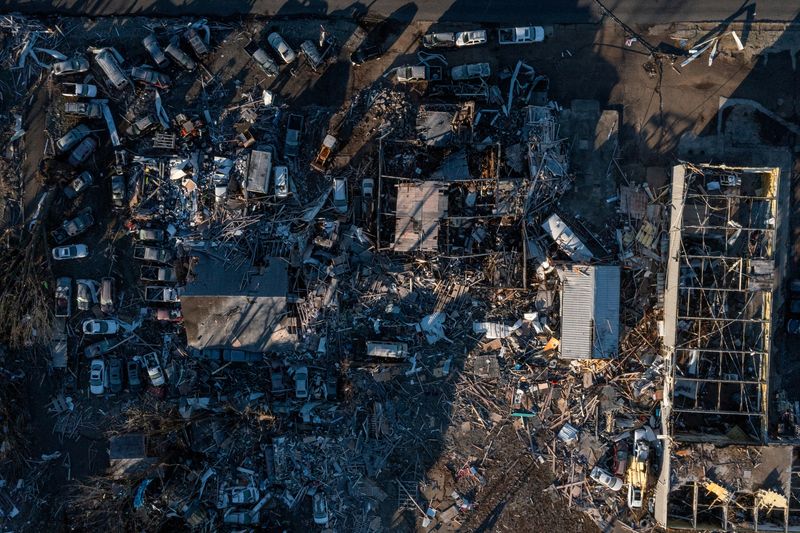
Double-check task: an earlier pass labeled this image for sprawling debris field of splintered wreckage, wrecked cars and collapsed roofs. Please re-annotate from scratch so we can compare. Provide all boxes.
[0,18,760,532]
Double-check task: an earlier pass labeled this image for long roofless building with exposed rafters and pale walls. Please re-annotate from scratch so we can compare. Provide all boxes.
[655,164,800,531]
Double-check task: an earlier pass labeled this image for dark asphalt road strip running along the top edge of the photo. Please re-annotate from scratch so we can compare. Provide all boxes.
[0,0,800,24]
